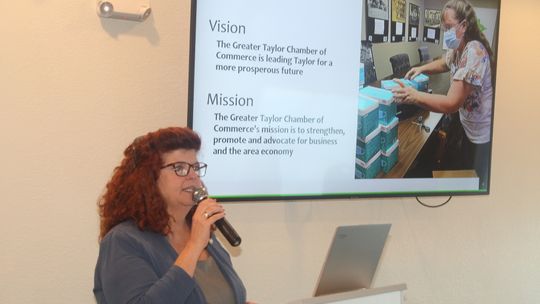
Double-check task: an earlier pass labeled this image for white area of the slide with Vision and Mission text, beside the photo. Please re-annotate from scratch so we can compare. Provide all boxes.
[190,0,478,199]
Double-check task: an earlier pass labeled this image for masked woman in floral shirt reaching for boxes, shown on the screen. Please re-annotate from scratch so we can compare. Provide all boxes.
[393,0,495,188]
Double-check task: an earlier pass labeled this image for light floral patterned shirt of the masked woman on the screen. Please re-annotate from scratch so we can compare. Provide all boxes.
[446,40,493,144]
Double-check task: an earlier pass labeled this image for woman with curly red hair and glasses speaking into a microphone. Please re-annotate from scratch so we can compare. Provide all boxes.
[94,127,251,304]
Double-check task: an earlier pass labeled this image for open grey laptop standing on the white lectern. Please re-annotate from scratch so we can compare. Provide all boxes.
[314,224,392,297]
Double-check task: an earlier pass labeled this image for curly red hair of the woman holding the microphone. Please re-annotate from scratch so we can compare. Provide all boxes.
[98,127,201,239]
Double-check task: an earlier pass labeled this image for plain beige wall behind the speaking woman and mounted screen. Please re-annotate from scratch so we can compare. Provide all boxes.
[0,0,540,304]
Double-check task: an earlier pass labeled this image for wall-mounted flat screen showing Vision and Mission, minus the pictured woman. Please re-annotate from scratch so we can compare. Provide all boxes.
[188,0,499,200]
